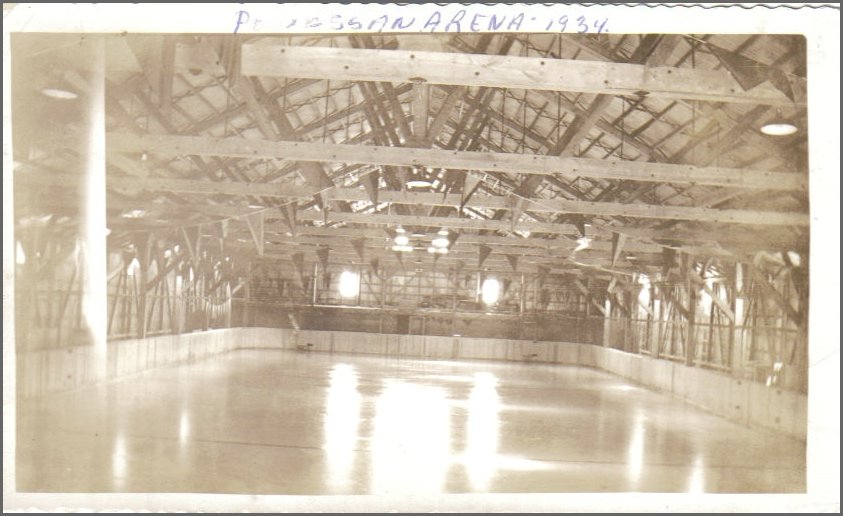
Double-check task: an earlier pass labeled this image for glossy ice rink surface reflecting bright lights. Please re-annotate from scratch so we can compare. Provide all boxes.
[16,350,806,495]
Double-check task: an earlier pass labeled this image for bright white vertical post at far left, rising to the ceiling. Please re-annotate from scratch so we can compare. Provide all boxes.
[80,37,108,379]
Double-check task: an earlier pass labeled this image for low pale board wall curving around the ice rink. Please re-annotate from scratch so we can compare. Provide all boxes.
[17,328,808,440]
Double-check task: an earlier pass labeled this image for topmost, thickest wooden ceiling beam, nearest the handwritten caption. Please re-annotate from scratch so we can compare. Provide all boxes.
[242,44,806,106]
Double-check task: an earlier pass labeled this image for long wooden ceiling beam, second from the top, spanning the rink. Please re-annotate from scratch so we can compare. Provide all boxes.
[107,133,808,192]
